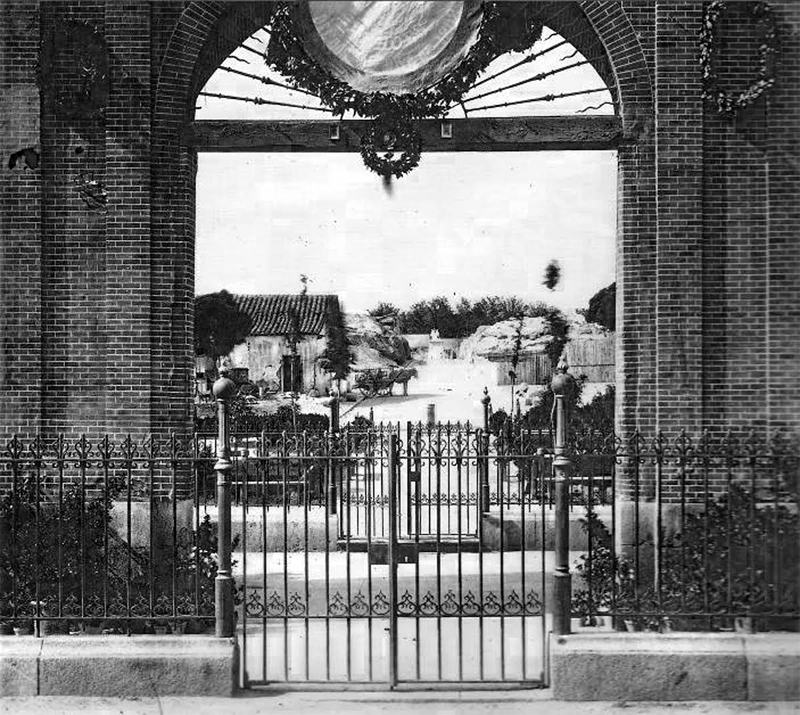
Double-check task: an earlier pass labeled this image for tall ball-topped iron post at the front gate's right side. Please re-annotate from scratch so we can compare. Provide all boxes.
[550,363,572,635]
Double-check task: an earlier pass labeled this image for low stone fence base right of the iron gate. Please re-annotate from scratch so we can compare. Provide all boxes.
[550,633,800,701]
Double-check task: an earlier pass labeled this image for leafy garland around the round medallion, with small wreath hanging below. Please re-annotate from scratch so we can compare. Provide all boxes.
[265,2,542,180]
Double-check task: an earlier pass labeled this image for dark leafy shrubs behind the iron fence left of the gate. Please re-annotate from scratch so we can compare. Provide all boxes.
[0,478,239,625]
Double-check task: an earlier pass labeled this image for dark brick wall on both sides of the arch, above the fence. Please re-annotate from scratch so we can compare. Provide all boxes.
[0,0,800,448]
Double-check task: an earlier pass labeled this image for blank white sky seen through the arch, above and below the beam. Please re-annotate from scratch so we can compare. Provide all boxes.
[196,24,616,311]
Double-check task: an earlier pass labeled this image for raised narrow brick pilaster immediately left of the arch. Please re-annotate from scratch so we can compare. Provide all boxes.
[104,1,152,435]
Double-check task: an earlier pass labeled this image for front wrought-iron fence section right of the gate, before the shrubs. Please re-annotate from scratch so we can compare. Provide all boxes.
[572,432,800,631]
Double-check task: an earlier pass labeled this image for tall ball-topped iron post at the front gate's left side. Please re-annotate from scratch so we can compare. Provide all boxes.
[213,377,236,638]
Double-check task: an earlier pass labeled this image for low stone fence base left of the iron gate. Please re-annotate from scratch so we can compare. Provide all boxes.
[0,636,239,698]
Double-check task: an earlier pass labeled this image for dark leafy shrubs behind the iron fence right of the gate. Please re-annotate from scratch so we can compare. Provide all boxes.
[572,484,800,630]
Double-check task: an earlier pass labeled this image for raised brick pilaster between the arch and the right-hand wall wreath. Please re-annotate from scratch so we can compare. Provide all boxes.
[653,2,703,431]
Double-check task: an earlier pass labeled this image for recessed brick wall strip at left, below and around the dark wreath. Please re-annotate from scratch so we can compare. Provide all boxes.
[41,0,106,437]
